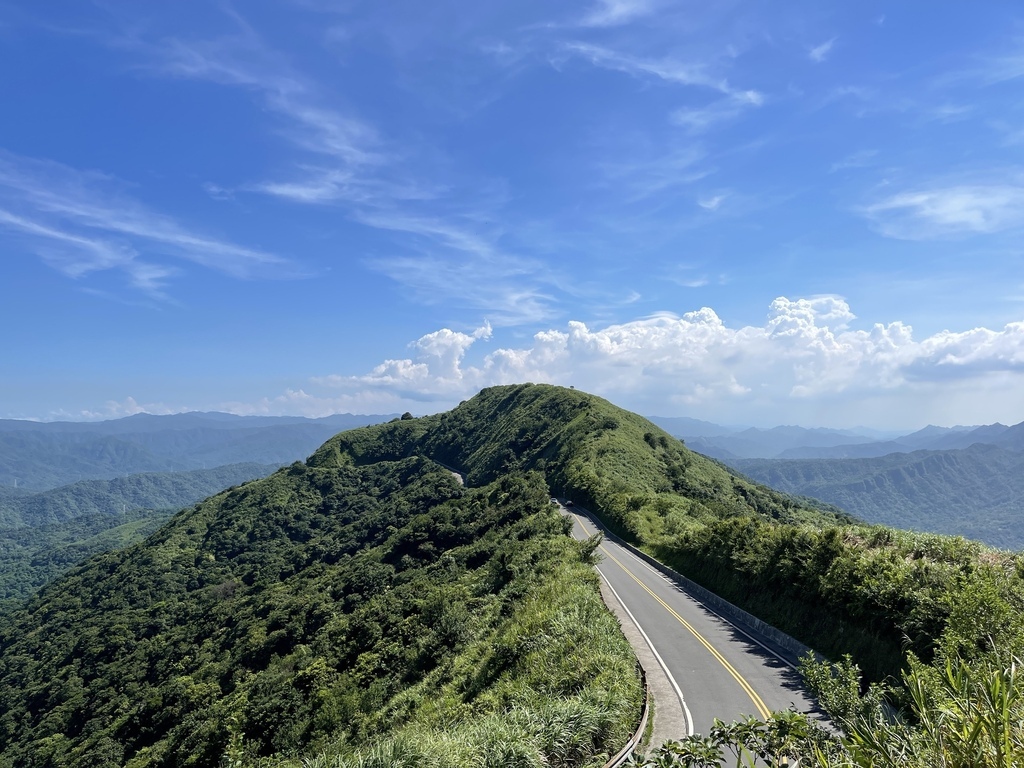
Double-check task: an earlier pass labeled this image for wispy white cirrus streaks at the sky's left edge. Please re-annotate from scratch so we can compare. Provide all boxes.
[0,153,290,297]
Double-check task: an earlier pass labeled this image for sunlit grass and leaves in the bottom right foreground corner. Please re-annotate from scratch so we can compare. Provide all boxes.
[637,659,1024,768]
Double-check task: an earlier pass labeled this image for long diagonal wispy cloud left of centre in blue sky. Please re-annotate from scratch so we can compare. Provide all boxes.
[133,20,565,324]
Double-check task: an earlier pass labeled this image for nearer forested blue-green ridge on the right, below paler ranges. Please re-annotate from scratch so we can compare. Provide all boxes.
[731,443,1024,550]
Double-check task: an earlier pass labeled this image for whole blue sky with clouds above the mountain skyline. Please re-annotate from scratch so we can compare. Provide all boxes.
[0,0,1024,429]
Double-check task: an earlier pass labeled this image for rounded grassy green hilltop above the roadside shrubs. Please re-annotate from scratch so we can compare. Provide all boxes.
[311,384,850,541]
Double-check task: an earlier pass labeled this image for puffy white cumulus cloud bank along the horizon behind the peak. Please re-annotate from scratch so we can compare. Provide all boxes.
[77,296,1024,428]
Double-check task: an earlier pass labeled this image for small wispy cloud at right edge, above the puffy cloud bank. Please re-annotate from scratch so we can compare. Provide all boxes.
[862,183,1024,240]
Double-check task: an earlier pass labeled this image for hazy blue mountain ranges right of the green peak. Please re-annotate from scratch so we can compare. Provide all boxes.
[654,419,1024,550]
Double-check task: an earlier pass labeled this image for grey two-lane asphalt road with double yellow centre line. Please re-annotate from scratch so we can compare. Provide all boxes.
[562,507,814,738]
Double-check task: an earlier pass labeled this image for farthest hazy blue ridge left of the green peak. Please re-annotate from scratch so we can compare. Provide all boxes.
[0,413,393,489]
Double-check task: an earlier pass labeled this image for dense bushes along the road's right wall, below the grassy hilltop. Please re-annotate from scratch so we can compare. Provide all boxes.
[650,518,1024,680]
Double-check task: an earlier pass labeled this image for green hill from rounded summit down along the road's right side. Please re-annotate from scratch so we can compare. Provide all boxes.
[311,385,1024,679]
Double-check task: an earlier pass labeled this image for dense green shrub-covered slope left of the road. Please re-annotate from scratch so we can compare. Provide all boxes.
[0,457,640,768]
